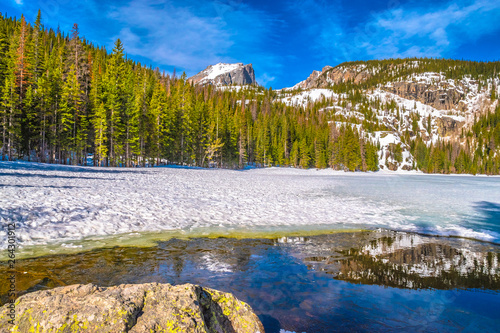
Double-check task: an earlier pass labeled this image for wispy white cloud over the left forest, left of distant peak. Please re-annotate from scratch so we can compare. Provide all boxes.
[110,0,232,68]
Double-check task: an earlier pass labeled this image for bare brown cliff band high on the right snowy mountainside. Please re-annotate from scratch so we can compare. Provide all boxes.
[383,82,464,110]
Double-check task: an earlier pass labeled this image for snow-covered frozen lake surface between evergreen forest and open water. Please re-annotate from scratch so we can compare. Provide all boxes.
[0,162,500,254]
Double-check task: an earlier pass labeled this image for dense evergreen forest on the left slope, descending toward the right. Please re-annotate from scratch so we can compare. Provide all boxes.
[0,12,378,171]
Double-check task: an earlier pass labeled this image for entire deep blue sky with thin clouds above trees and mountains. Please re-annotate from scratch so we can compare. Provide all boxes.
[0,0,500,88]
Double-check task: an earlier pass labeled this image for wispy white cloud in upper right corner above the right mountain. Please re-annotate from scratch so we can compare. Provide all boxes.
[362,0,500,58]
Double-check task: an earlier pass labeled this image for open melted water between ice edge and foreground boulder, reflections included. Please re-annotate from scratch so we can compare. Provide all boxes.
[0,231,500,333]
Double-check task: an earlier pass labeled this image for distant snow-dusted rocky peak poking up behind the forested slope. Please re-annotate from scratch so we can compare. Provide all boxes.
[188,63,256,85]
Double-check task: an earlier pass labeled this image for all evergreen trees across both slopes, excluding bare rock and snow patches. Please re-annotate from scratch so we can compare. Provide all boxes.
[0,12,500,174]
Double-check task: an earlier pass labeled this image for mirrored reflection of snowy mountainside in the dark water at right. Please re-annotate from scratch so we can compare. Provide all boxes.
[292,232,500,290]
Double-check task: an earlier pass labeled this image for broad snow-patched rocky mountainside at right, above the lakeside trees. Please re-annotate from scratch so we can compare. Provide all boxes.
[278,60,500,170]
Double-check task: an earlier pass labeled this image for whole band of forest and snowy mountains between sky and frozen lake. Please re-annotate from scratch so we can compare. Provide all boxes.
[0,15,500,174]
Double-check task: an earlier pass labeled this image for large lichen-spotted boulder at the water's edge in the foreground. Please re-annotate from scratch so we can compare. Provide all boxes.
[0,283,264,333]
